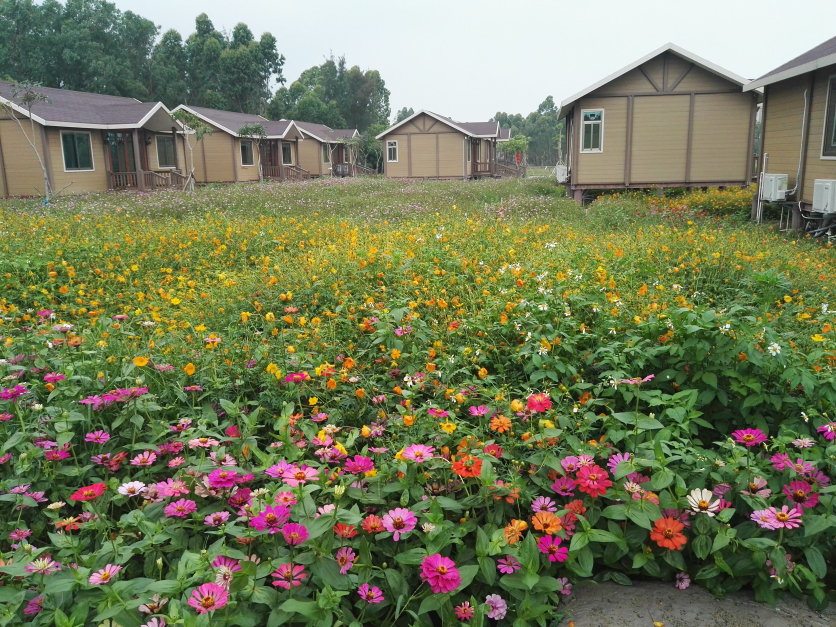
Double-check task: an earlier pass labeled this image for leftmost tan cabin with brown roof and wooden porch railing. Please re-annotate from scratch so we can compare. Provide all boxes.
[0,81,186,197]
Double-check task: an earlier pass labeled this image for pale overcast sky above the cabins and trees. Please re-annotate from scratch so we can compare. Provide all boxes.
[115,0,836,121]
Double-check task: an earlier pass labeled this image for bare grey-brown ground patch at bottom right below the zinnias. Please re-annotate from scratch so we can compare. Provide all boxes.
[555,582,836,627]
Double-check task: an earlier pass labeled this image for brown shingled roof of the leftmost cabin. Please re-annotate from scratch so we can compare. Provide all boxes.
[0,81,164,128]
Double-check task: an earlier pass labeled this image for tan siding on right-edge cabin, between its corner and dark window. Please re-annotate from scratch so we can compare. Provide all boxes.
[761,74,808,190]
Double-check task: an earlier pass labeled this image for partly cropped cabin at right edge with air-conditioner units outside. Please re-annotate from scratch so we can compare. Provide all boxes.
[743,37,836,228]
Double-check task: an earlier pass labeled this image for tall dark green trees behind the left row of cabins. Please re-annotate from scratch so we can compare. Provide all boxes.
[0,0,390,132]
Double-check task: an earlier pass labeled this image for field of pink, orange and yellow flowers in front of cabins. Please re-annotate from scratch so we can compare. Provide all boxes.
[0,180,836,627]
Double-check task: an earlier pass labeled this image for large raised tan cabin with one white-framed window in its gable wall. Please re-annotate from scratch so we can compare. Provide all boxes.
[558,44,760,201]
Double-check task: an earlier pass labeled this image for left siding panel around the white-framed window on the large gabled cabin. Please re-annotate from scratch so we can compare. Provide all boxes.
[575,97,627,185]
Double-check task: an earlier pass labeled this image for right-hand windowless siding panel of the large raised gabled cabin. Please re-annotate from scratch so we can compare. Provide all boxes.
[691,92,752,183]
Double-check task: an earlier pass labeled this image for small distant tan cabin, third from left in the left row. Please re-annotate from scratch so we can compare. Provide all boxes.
[296,122,376,177]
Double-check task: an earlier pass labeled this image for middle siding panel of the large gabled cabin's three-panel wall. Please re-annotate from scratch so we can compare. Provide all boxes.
[632,95,688,185]
